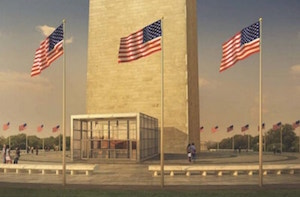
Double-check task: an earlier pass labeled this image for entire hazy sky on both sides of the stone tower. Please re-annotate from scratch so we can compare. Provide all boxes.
[0,0,300,141]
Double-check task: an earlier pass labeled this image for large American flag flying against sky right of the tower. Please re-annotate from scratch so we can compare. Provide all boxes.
[219,22,260,72]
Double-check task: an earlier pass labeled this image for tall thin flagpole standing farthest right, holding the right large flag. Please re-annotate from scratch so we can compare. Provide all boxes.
[259,18,263,187]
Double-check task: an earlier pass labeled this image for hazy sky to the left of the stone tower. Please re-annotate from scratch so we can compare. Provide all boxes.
[0,0,89,137]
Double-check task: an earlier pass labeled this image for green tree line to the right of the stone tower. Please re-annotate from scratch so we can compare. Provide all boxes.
[207,124,300,152]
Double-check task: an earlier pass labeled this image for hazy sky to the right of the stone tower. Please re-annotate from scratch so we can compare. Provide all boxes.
[197,0,300,140]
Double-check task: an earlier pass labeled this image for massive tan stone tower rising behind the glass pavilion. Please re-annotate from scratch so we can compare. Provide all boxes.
[86,0,200,153]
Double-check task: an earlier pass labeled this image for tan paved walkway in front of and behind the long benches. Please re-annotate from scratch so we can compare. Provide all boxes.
[0,152,300,187]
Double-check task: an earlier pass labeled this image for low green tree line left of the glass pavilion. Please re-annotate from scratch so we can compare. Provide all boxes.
[0,133,70,150]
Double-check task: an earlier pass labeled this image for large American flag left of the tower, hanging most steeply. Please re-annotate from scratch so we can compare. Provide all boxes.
[31,24,64,77]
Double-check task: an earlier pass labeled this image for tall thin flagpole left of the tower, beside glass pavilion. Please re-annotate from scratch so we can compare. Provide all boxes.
[62,19,66,186]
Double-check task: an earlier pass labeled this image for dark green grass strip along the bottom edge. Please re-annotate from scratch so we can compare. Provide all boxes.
[0,188,300,197]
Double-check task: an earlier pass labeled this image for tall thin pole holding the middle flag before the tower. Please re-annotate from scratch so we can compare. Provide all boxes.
[160,17,165,187]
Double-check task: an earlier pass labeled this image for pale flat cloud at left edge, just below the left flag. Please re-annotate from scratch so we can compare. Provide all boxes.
[0,71,53,92]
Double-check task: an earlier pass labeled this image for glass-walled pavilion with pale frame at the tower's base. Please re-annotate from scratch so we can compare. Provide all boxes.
[71,113,159,162]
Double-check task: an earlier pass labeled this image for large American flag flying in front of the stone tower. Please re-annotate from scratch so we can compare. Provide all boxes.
[119,20,162,63]
